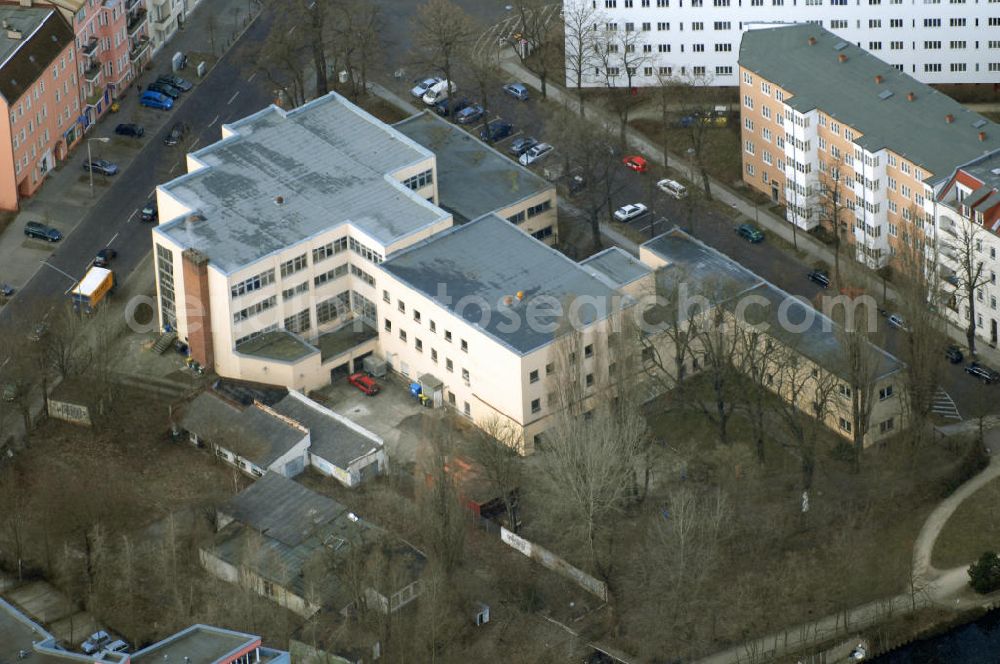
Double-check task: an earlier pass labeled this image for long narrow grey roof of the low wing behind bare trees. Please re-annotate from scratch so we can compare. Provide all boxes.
[643,228,903,378]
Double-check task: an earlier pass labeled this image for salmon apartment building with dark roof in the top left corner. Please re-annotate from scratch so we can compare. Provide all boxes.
[0,5,82,210]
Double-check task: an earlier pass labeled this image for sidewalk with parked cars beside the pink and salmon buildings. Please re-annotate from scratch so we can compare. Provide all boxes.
[0,0,259,290]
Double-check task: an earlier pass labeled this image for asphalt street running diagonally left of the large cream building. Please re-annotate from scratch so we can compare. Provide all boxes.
[0,13,274,334]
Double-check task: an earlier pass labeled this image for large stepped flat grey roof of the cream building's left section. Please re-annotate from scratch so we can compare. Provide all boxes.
[154,92,447,273]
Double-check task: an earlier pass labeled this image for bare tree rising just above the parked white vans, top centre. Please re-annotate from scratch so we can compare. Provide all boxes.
[413,0,478,109]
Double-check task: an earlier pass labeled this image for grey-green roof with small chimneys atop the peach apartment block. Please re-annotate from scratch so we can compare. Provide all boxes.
[739,23,1000,179]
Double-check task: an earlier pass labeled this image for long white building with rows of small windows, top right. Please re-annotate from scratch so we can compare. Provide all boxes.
[563,0,1000,86]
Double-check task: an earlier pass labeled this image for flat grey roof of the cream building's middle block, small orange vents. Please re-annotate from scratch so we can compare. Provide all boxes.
[381,214,622,354]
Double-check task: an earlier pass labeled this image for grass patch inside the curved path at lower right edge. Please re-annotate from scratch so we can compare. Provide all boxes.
[931,472,1000,569]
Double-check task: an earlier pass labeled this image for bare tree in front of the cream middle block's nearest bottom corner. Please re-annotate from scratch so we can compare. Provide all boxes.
[470,416,523,533]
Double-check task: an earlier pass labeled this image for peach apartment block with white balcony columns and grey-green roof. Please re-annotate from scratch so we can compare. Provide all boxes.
[739,25,1000,268]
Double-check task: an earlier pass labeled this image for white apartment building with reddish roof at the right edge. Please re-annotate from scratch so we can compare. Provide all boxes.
[925,151,1000,347]
